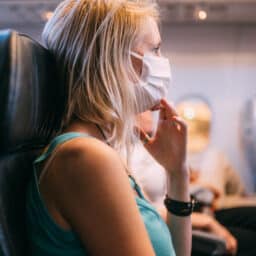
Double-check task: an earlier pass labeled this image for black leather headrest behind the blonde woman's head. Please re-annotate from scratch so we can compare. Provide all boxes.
[0,30,66,156]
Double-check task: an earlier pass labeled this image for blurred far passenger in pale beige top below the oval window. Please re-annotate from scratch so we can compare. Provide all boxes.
[188,146,246,208]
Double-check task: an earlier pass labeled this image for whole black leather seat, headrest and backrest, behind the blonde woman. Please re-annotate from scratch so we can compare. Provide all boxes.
[0,30,65,256]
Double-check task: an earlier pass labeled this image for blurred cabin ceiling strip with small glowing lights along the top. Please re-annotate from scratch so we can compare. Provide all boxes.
[0,0,256,27]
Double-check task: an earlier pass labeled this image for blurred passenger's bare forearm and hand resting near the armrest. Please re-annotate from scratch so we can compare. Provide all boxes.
[191,213,237,255]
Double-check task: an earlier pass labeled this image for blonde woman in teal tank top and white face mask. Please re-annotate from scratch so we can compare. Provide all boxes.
[27,0,191,256]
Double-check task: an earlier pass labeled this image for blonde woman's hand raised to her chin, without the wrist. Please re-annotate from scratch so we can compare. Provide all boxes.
[140,99,188,176]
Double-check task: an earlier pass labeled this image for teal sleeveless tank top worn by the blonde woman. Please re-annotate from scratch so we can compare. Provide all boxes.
[26,132,175,256]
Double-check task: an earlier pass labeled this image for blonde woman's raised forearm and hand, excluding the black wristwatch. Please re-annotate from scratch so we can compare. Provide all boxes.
[140,100,192,256]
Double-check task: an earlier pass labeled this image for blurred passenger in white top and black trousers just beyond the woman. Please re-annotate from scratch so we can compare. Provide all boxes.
[130,111,256,256]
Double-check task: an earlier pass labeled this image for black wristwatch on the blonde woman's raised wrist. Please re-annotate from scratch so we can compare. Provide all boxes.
[164,195,196,217]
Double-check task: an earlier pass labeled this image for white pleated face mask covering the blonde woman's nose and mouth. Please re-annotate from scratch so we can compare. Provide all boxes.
[131,52,171,113]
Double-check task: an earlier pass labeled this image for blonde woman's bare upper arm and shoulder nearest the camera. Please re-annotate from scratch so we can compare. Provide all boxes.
[49,139,155,256]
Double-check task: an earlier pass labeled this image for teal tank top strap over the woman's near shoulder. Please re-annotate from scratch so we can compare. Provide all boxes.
[34,132,92,164]
